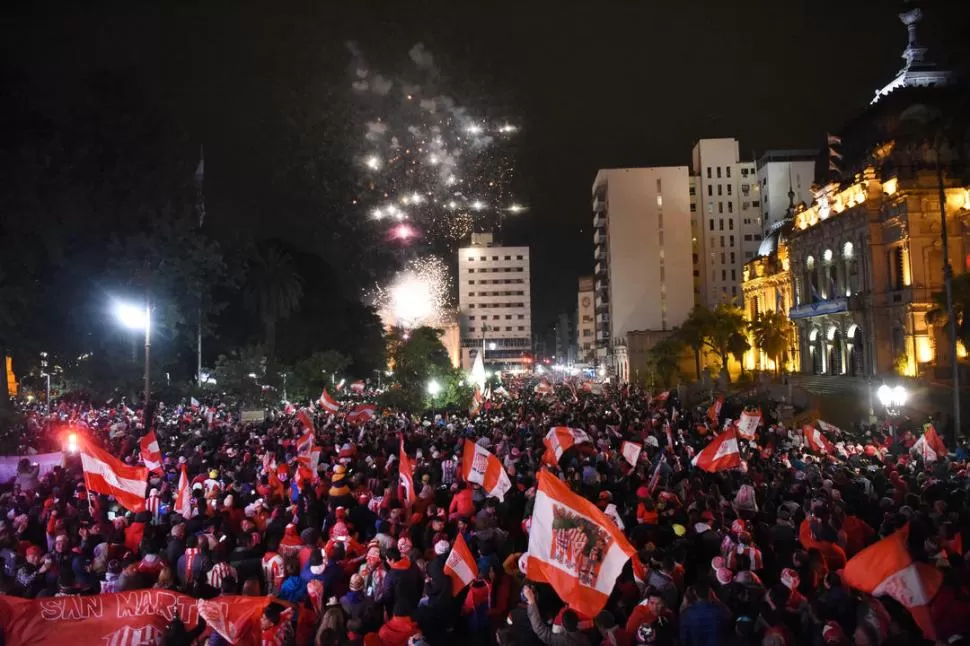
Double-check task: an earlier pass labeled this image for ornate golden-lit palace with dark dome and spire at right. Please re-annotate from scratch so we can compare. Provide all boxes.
[784,2,970,376]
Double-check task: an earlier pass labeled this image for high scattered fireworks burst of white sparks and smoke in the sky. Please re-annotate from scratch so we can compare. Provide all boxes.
[349,44,523,252]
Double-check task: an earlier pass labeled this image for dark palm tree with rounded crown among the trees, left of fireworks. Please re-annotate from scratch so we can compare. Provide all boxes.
[245,247,303,361]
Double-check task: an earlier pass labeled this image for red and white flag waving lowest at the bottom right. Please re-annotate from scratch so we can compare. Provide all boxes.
[842,524,943,639]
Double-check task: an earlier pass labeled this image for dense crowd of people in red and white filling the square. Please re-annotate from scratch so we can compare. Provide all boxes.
[0,380,970,646]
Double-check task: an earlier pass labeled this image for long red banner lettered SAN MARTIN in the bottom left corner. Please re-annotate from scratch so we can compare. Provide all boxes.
[0,589,272,646]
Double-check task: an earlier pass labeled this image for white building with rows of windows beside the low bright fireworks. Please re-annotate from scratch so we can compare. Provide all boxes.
[458,233,532,370]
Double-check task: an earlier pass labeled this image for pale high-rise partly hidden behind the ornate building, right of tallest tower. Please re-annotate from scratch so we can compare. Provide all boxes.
[758,150,818,233]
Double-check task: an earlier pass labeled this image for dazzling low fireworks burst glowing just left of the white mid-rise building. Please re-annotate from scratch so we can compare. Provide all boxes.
[373,256,451,330]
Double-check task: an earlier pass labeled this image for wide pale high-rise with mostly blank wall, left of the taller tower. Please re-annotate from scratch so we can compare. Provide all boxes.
[593,166,694,382]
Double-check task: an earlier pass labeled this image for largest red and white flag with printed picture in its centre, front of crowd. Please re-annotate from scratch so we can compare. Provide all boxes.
[526,471,636,617]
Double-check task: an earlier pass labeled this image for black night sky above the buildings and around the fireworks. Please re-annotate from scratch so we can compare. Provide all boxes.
[0,0,967,340]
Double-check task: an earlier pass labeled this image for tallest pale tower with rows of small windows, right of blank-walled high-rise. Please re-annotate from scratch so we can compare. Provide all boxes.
[690,139,763,308]
